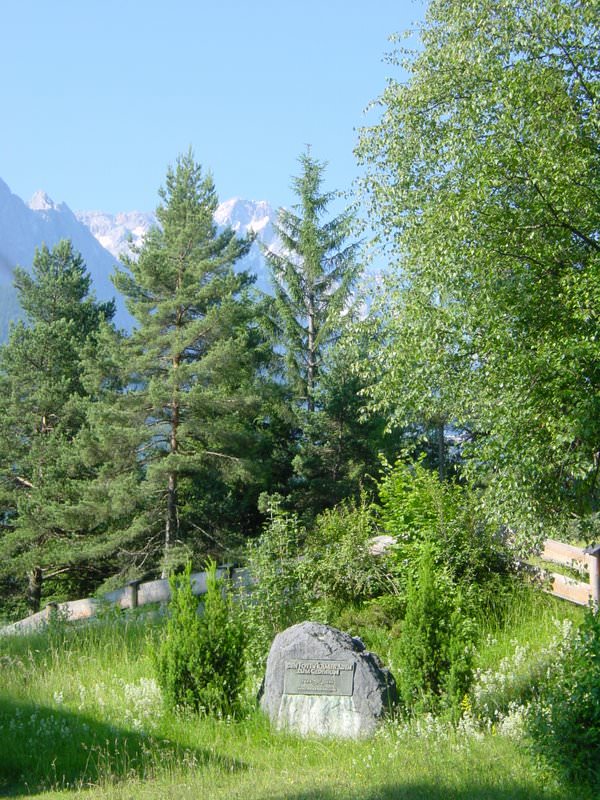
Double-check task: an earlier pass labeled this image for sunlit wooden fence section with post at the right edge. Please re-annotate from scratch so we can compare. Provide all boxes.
[540,539,600,608]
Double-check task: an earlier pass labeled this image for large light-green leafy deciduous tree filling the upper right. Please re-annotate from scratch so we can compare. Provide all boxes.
[360,0,600,545]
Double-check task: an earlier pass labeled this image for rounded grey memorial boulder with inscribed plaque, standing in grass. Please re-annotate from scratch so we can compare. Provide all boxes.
[260,622,396,739]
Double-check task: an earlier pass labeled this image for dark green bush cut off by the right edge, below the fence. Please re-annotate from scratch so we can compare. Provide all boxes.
[526,610,600,786]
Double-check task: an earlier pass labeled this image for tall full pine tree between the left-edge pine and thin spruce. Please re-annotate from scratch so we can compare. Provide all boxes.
[89,152,279,572]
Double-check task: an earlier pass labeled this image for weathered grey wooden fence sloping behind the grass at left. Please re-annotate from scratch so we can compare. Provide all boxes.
[0,566,250,635]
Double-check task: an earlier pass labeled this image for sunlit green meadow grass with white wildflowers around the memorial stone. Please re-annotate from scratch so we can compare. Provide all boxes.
[0,592,593,800]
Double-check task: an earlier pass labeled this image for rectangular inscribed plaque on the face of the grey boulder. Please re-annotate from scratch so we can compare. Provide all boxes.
[283,659,355,697]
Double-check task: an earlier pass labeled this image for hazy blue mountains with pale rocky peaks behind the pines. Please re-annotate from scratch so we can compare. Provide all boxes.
[0,179,276,342]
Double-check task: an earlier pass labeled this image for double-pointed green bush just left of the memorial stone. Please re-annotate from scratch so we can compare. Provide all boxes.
[155,561,245,716]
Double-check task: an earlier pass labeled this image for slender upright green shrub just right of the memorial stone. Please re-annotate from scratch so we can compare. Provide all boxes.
[398,545,474,717]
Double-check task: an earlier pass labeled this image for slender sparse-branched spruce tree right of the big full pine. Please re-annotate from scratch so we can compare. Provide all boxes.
[264,152,363,515]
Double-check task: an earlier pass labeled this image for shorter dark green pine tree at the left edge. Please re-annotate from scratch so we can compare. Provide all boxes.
[0,241,114,610]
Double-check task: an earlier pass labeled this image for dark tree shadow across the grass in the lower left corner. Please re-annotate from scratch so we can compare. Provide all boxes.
[0,697,245,797]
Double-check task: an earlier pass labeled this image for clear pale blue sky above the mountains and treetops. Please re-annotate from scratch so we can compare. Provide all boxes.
[0,0,424,213]
